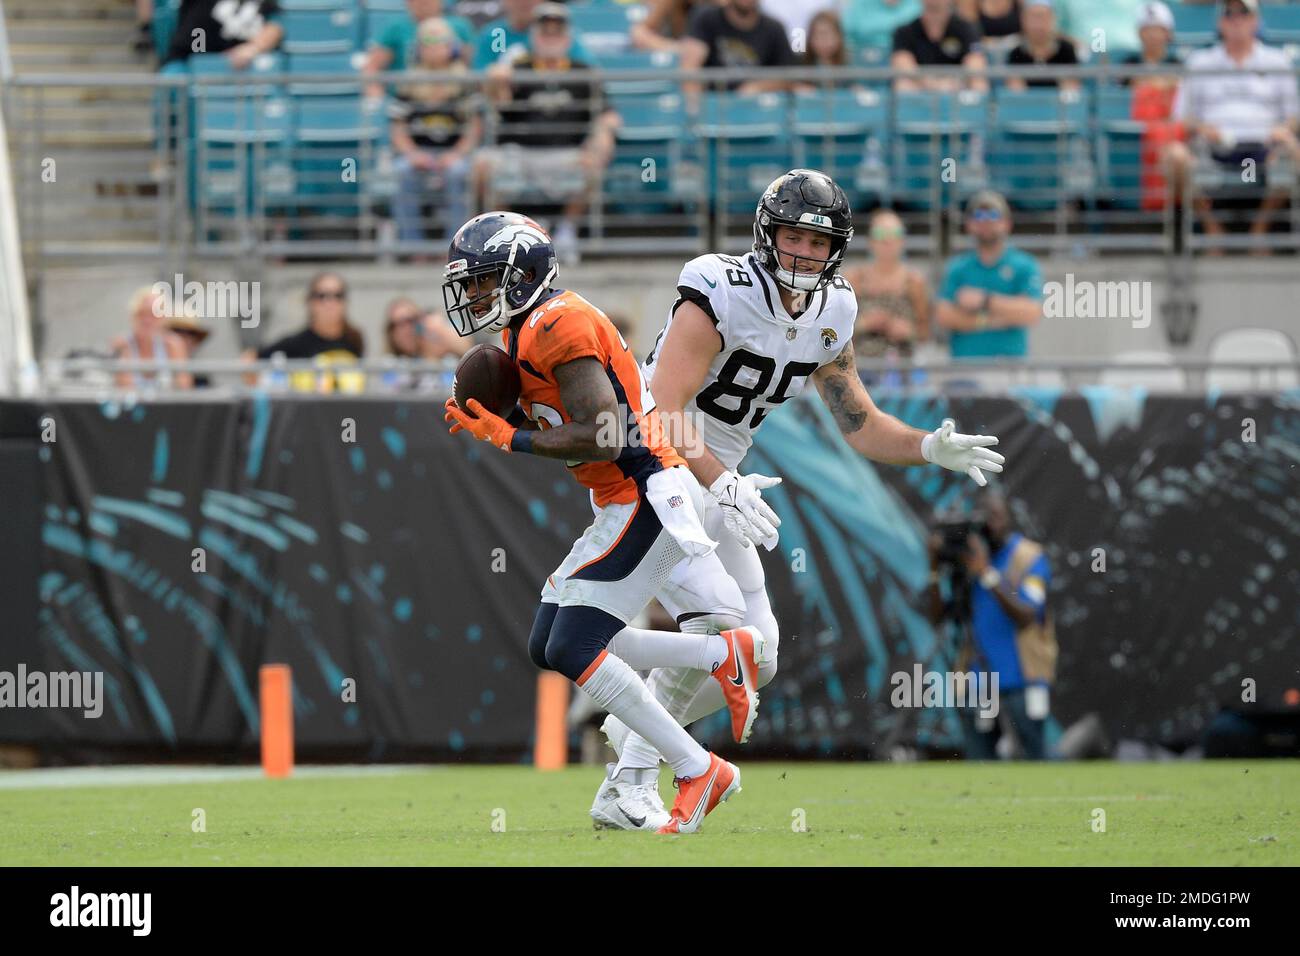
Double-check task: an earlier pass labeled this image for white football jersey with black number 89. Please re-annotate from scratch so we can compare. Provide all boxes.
[644,254,858,470]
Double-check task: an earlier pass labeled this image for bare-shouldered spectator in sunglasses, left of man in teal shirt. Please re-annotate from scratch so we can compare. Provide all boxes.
[844,209,930,369]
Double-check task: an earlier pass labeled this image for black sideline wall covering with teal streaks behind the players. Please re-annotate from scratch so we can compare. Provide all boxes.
[0,389,1300,760]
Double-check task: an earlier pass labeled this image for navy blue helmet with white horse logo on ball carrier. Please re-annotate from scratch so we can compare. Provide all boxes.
[442,212,559,336]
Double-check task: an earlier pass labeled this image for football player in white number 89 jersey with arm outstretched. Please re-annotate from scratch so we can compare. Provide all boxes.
[592,169,1005,818]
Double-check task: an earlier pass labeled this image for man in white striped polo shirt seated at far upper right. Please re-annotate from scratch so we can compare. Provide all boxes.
[1166,0,1300,252]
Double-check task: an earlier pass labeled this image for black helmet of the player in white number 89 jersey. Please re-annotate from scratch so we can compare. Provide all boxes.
[754,169,853,293]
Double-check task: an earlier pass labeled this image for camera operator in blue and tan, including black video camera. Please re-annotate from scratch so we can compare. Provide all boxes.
[930,490,1057,760]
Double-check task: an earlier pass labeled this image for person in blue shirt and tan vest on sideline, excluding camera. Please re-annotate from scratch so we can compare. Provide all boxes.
[966,490,1057,760]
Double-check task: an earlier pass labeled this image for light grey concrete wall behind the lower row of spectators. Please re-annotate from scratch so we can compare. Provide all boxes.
[30,256,1300,358]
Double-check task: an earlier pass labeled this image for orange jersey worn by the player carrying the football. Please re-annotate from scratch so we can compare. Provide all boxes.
[502,290,685,506]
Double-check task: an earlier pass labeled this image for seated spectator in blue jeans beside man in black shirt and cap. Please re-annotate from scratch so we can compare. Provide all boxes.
[389,17,482,251]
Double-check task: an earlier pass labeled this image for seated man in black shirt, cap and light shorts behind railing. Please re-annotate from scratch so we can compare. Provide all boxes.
[475,3,619,264]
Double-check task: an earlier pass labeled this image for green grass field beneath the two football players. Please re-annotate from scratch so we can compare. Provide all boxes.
[0,761,1300,866]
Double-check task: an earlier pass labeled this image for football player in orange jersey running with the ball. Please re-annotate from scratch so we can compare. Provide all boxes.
[443,212,767,832]
